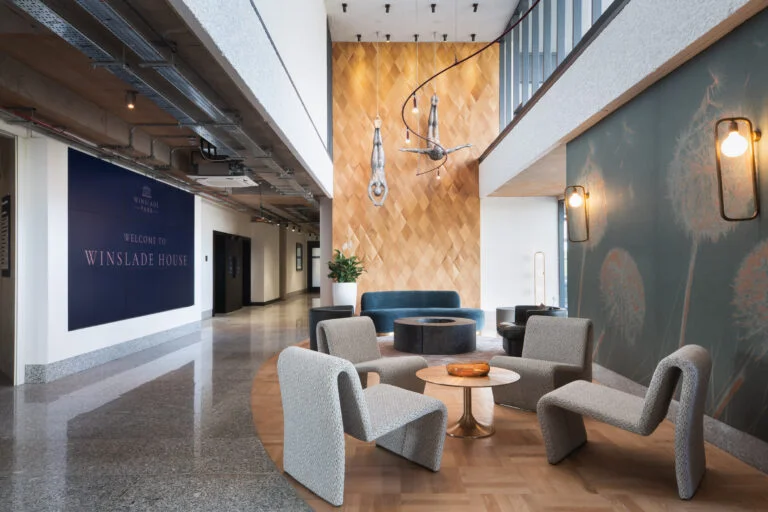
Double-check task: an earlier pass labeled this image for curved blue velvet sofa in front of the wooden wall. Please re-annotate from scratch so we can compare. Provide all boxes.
[360,291,485,334]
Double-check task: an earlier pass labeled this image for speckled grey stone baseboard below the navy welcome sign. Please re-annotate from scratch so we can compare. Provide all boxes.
[24,321,200,383]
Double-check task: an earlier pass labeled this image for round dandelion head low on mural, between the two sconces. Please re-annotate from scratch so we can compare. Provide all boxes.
[593,248,645,355]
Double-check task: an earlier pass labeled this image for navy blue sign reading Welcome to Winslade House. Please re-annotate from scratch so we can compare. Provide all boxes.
[69,149,195,331]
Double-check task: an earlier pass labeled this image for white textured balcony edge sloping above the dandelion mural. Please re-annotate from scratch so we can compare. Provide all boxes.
[480,0,765,197]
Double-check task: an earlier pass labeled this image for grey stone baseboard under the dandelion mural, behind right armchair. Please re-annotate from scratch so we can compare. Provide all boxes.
[592,363,768,473]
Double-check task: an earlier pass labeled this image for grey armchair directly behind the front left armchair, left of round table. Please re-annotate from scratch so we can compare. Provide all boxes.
[317,316,427,393]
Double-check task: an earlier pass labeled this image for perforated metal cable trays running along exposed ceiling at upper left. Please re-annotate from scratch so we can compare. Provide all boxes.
[13,0,317,216]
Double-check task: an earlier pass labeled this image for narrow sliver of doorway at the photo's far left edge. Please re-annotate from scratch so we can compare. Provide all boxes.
[0,133,16,386]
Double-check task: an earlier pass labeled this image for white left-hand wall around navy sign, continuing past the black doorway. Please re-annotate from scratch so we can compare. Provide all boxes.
[6,121,296,384]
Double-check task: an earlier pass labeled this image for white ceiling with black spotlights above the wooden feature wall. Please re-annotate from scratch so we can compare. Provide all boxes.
[325,0,519,42]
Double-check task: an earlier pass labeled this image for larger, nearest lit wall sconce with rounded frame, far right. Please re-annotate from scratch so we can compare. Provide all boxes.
[715,117,760,221]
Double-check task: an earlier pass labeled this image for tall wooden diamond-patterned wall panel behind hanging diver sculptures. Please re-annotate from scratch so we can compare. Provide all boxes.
[333,43,499,307]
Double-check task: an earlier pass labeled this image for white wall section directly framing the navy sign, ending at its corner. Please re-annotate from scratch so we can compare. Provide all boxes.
[17,136,200,375]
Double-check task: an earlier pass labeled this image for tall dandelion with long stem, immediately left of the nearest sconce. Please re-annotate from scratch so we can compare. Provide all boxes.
[667,75,736,346]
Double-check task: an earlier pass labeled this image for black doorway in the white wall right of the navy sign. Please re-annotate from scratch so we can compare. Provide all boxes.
[213,231,251,315]
